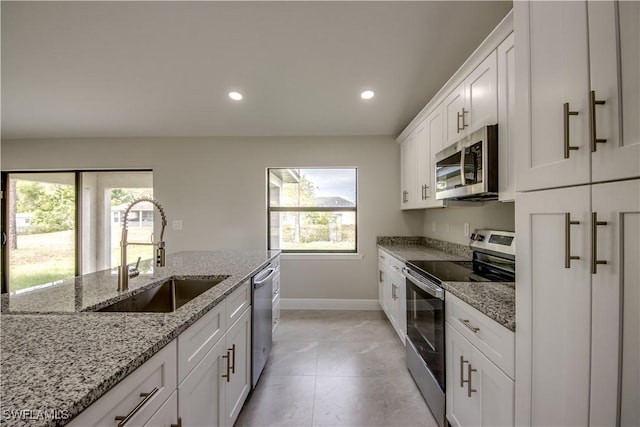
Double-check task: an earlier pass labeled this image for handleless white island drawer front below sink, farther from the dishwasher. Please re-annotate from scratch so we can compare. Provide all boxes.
[178,303,226,384]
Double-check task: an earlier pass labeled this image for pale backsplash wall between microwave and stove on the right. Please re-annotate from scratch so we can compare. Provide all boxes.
[422,201,515,245]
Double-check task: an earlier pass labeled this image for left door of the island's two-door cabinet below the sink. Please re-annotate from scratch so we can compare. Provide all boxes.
[178,339,227,427]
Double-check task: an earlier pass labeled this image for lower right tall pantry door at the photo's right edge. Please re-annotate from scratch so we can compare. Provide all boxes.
[589,180,640,426]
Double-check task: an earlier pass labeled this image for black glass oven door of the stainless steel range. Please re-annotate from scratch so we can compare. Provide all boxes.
[405,273,445,392]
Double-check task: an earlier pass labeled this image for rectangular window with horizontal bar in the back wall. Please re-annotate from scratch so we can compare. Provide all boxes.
[267,168,358,253]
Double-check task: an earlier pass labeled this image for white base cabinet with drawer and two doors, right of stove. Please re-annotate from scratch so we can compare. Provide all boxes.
[445,294,515,427]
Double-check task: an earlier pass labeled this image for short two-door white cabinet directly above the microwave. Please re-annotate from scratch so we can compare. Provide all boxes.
[443,51,498,148]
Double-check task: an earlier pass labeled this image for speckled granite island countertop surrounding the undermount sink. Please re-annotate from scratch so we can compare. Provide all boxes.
[0,250,279,426]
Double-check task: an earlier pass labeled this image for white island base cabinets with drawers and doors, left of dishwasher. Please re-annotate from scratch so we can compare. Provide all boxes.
[69,282,251,427]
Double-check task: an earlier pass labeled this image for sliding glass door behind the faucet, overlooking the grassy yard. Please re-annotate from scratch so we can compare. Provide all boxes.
[2,171,154,293]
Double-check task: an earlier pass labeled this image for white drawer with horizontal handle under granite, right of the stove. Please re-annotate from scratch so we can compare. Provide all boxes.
[445,292,515,378]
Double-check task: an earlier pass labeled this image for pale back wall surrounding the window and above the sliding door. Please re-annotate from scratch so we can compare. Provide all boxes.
[1,137,423,300]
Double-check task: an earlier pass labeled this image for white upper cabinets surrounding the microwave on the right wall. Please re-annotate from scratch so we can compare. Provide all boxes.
[398,13,515,209]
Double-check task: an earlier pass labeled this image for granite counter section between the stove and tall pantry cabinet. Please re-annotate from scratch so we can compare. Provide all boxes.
[442,282,516,332]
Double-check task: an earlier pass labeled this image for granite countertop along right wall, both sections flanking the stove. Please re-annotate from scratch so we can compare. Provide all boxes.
[378,237,516,332]
